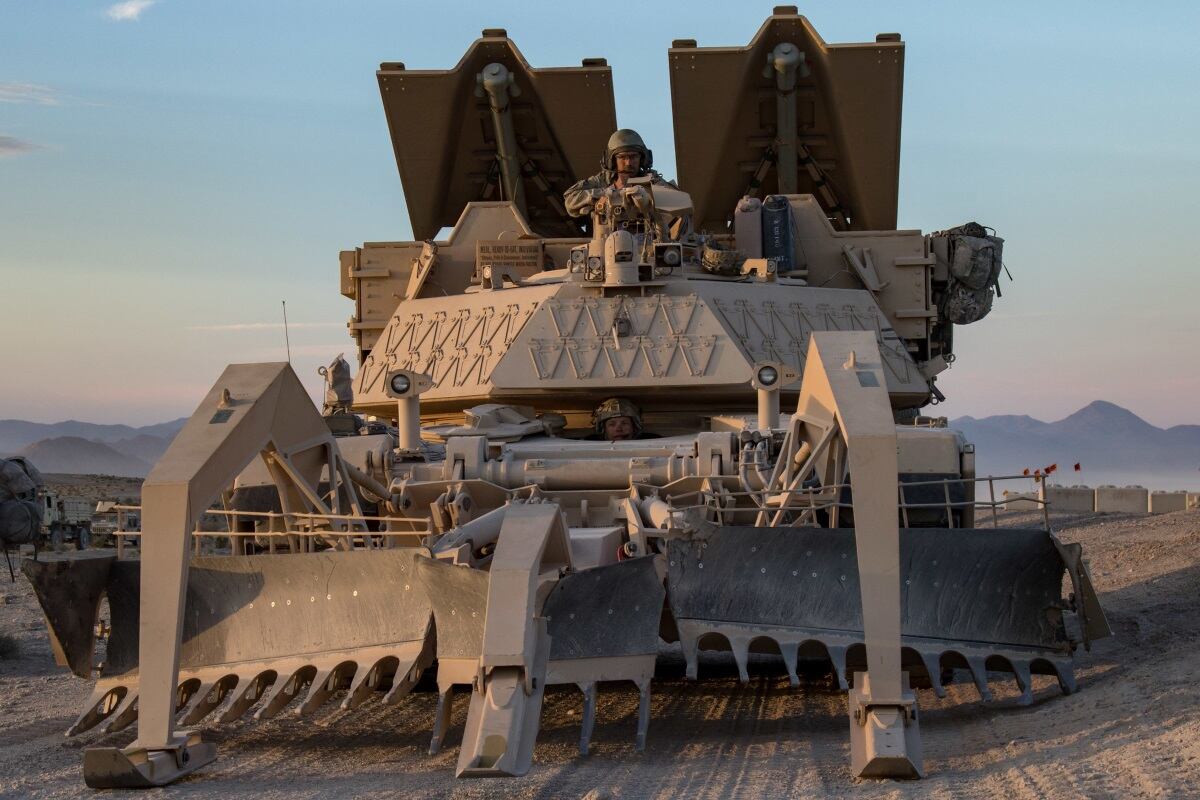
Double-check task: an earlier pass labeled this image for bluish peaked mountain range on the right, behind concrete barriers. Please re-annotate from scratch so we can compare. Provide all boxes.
[950,401,1200,491]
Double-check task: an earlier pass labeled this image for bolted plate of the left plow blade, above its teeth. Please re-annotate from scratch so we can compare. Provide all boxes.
[102,548,431,675]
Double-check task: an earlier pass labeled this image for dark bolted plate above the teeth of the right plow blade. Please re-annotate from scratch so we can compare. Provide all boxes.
[667,527,1069,651]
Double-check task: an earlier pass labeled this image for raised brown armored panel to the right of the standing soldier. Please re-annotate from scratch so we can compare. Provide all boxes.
[668,6,904,233]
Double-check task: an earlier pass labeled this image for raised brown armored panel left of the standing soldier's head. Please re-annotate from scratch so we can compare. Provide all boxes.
[378,29,617,240]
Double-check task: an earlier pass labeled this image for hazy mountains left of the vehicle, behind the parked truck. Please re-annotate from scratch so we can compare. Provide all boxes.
[0,417,187,477]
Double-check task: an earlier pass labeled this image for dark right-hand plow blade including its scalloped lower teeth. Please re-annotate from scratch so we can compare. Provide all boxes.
[667,527,1104,703]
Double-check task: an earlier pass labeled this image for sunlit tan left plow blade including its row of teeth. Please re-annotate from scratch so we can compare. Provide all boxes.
[24,548,433,734]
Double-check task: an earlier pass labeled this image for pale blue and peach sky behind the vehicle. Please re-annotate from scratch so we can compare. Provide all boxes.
[0,0,1200,426]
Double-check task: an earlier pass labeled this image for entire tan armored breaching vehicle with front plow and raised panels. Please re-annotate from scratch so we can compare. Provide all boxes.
[25,7,1108,787]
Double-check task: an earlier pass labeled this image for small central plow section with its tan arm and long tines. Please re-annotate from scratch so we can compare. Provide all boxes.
[418,504,664,777]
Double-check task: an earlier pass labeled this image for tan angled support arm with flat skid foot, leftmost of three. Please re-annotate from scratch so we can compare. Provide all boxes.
[84,363,337,788]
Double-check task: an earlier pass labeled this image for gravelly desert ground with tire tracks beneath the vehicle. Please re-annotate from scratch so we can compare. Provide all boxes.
[0,503,1200,800]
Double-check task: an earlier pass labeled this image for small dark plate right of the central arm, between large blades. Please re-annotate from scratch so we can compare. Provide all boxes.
[542,557,666,661]
